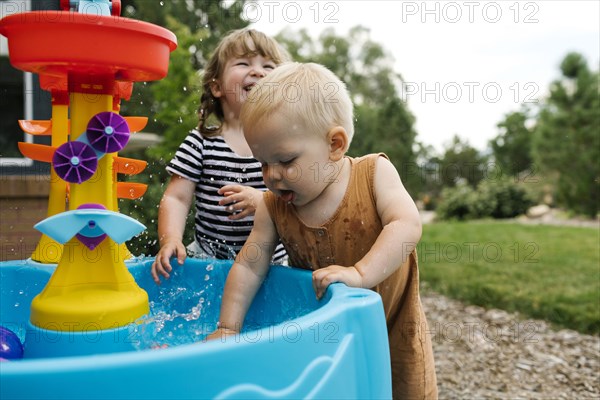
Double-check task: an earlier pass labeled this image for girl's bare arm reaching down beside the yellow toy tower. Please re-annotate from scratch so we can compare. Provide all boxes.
[151,175,196,284]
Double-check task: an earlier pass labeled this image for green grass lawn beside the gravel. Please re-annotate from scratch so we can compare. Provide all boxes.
[417,221,600,335]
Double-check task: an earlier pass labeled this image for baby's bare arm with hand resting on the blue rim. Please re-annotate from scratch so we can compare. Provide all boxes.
[313,157,421,298]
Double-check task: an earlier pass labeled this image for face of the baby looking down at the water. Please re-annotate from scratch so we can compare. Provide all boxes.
[244,115,339,207]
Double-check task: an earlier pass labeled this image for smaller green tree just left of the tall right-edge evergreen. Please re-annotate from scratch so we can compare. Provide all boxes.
[490,107,533,176]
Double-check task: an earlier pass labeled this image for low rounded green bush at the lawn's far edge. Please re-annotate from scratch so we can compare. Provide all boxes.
[436,178,534,220]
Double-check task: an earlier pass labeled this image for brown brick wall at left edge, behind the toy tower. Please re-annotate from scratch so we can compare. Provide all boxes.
[0,175,50,261]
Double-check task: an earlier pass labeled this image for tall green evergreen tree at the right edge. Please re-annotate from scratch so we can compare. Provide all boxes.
[533,53,600,217]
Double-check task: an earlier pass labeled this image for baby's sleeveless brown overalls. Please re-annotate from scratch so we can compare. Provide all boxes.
[264,154,437,400]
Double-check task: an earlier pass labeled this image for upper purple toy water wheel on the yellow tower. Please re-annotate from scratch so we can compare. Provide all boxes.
[86,111,129,153]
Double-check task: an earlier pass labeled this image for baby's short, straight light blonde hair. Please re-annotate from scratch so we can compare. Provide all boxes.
[240,63,354,144]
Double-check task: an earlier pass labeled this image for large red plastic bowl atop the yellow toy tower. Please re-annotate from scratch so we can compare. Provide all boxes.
[0,11,177,82]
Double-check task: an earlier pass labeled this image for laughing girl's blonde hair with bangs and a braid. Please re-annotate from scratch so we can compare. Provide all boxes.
[198,28,289,137]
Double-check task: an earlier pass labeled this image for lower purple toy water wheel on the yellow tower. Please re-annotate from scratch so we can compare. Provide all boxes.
[52,141,98,183]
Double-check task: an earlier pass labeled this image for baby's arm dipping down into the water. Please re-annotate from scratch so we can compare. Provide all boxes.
[209,199,278,339]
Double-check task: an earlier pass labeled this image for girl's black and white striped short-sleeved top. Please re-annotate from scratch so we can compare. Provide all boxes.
[167,130,285,263]
